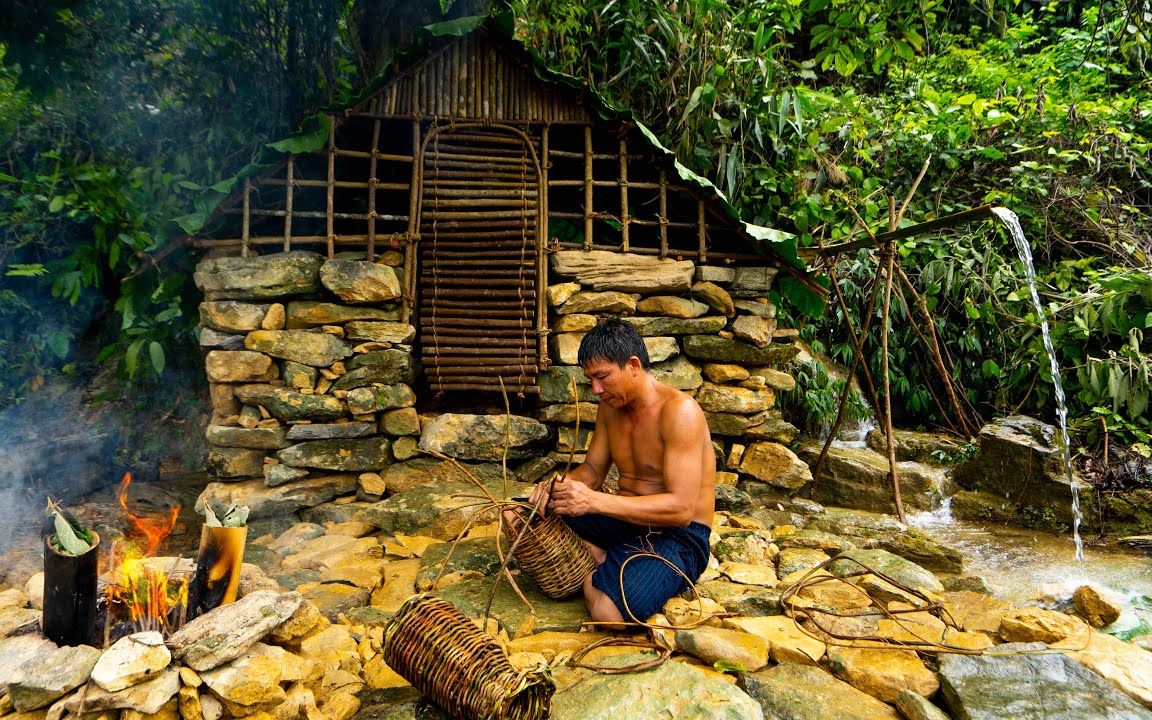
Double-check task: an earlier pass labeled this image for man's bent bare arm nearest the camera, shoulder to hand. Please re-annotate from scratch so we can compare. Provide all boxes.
[552,397,707,528]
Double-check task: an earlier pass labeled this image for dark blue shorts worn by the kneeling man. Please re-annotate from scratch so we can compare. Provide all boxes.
[562,515,712,622]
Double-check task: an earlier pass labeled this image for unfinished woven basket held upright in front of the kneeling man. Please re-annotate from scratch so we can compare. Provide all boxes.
[507,508,596,600]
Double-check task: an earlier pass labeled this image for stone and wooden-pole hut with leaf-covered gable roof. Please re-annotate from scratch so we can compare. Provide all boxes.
[192,21,814,516]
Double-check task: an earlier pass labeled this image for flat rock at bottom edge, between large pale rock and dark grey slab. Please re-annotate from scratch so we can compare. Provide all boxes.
[740,662,900,720]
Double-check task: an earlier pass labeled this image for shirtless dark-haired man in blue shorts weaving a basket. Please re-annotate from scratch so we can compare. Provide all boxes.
[533,319,715,622]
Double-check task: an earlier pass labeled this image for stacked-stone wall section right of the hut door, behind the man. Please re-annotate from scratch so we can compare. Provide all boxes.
[537,250,811,497]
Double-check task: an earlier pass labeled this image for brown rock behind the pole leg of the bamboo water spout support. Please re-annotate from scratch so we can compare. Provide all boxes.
[799,444,952,513]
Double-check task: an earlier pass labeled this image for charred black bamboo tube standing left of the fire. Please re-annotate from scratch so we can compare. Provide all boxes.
[40,532,100,645]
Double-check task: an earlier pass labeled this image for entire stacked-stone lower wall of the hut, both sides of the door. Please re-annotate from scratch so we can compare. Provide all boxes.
[196,246,811,517]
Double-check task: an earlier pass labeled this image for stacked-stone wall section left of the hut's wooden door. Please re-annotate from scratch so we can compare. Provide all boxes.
[195,251,419,513]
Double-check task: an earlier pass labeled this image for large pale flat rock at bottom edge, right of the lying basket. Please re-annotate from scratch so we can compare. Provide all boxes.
[548,653,764,720]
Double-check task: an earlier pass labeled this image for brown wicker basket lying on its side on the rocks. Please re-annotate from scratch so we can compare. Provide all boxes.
[382,593,555,720]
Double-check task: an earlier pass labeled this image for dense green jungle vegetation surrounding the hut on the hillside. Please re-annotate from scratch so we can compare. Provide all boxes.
[0,0,1152,476]
